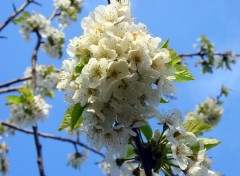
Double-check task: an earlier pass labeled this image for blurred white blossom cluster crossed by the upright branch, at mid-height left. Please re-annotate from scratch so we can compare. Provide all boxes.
[24,65,58,97]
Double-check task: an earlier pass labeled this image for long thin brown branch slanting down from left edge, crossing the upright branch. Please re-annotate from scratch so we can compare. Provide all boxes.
[0,121,104,157]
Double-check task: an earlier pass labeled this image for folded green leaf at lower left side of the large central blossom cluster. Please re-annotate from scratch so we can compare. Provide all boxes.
[58,103,86,131]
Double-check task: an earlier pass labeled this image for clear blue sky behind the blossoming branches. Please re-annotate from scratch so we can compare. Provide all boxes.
[0,0,240,176]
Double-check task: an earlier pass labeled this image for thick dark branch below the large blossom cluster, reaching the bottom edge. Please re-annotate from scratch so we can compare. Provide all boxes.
[133,129,152,176]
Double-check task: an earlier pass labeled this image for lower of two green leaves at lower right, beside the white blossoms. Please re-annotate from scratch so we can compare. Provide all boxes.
[191,138,221,152]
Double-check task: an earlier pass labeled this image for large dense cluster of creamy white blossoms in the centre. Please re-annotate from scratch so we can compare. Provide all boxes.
[57,0,175,158]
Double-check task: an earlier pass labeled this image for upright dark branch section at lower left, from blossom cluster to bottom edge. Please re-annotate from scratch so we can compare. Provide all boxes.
[32,125,45,176]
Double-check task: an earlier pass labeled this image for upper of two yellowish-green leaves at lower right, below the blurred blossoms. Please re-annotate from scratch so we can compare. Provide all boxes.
[183,120,214,135]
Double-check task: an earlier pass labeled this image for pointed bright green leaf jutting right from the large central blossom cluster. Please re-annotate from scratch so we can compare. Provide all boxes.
[174,64,195,82]
